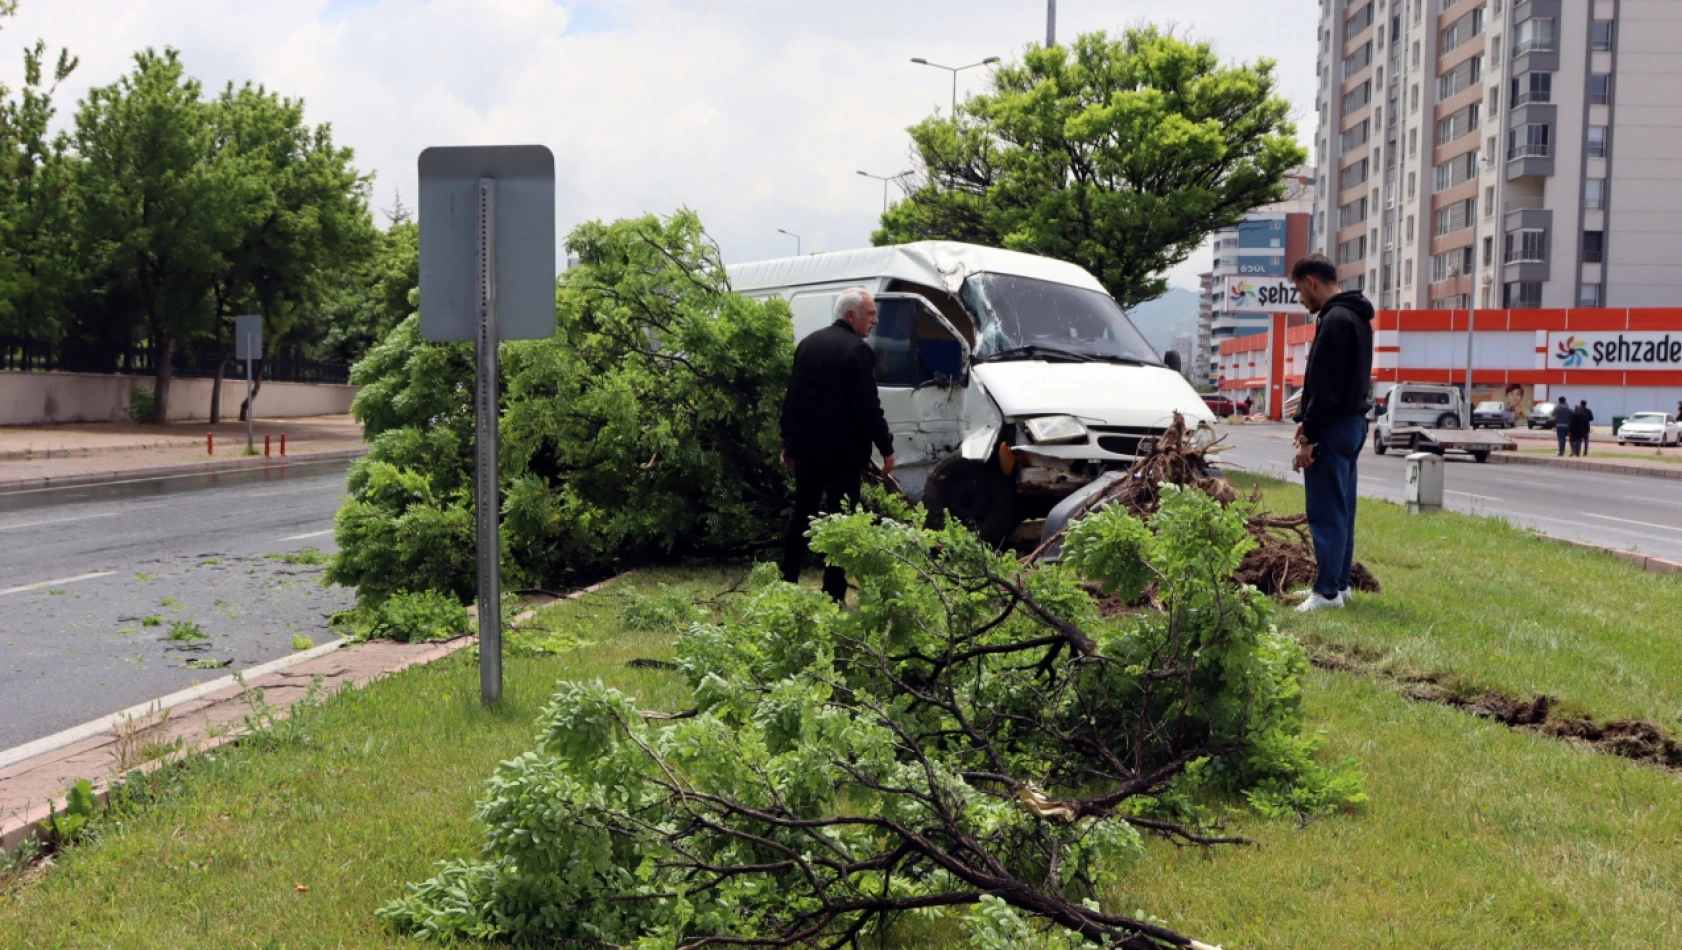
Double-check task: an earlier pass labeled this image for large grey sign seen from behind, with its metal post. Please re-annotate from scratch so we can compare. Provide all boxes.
[421,145,555,705]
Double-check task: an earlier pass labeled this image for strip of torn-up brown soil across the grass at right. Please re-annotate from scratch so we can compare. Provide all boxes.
[1312,644,1682,772]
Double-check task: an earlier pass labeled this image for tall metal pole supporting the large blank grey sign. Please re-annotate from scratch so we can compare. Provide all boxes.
[474,178,503,705]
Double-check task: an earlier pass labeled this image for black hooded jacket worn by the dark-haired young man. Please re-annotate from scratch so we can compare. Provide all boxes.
[1297,293,1373,442]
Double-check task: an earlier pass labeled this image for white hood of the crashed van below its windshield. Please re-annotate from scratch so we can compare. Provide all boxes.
[971,360,1214,429]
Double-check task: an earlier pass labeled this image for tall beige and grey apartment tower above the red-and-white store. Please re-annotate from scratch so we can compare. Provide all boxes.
[1310,0,1682,309]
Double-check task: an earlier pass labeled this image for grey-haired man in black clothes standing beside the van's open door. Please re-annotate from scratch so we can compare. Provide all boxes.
[782,288,893,602]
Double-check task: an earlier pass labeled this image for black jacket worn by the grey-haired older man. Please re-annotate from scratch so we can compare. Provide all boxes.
[782,319,893,471]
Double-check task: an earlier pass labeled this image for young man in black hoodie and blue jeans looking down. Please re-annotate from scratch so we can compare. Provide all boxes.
[1290,254,1373,612]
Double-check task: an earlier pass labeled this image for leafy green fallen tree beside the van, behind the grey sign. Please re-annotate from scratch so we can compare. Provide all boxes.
[328,212,794,602]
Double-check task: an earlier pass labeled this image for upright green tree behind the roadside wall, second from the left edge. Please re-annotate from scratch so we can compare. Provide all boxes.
[76,49,225,420]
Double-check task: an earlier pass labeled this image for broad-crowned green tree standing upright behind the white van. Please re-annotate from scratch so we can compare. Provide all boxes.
[873,27,1307,306]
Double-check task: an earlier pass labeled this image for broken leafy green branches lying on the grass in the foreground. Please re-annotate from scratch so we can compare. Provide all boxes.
[380,488,1361,950]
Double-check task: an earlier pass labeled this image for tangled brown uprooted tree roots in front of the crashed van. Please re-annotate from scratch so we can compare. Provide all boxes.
[1026,414,1383,598]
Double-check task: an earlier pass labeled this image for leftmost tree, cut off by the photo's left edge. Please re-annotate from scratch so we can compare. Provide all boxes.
[0,19,77,340]
